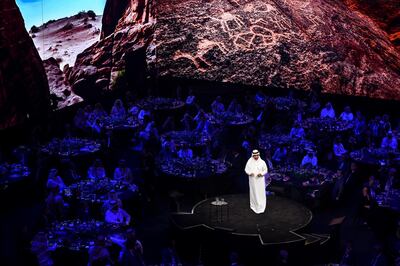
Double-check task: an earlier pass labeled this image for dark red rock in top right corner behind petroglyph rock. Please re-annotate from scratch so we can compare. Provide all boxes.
[344,0,400,51]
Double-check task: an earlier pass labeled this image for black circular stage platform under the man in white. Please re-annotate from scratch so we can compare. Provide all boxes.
[172,194,312,245]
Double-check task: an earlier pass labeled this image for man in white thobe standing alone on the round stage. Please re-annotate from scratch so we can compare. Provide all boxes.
[244,150,268,213]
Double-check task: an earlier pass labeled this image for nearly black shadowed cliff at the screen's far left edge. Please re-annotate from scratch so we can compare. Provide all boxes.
[0,0,49,129]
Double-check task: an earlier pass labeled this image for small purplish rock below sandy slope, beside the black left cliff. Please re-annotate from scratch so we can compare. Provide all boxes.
[43,57,82,109]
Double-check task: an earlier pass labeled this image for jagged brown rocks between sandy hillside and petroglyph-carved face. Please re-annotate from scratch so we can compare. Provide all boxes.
[66,0,154,100]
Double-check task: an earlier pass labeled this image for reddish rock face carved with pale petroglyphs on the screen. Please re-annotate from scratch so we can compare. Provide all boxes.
[154,0,400,100]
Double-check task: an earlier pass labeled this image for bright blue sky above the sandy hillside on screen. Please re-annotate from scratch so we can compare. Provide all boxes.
[16,0,106,30]
